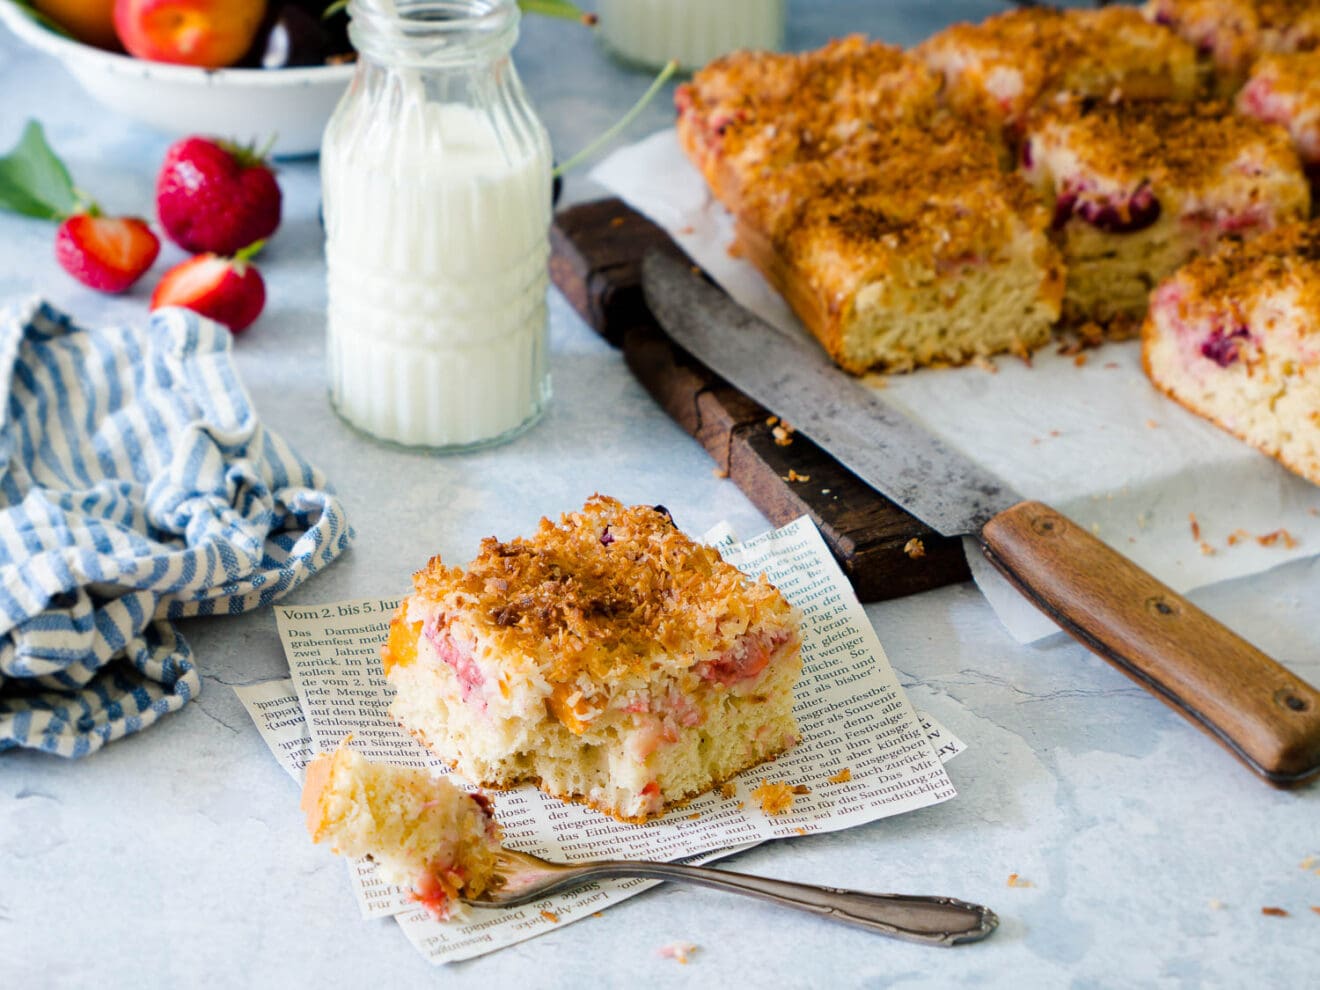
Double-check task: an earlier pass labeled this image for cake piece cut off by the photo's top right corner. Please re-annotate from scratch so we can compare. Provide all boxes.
[1144,0,1320,98]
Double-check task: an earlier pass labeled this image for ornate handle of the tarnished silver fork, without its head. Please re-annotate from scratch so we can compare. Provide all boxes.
[573,859,999,945]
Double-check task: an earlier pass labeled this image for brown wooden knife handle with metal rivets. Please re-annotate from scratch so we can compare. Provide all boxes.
[981,502,1320,787]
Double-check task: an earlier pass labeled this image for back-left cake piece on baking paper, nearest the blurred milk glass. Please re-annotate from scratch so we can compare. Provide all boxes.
[675,36,940,210]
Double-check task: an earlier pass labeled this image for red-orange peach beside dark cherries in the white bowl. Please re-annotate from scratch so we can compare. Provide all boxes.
[115,0,265,69]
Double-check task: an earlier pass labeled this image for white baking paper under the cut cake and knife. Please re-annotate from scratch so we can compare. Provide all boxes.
[591,131,1320,642]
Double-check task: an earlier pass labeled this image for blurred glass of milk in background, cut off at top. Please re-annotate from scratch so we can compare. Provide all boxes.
[595,0,785,70]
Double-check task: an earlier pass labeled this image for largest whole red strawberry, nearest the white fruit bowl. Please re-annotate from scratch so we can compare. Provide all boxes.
[156,137,280,255]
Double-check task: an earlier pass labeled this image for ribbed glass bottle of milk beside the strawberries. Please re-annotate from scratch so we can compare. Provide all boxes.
[321,0,550,450]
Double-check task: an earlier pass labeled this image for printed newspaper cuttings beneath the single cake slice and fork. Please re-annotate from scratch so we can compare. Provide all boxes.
[239,519,965,962]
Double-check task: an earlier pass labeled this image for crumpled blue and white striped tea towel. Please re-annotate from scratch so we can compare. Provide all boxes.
[0,301,352,756]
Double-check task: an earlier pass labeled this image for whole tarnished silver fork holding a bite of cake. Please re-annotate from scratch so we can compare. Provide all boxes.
[463,849,999,945]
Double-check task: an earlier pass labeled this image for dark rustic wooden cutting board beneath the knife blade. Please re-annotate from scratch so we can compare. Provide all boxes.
[550,199,969,602]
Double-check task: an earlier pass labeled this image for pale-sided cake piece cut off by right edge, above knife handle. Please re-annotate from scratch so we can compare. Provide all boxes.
[1142,220,1320,484]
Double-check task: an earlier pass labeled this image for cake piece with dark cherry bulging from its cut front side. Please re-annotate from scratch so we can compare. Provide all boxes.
[1022,100,1311,330]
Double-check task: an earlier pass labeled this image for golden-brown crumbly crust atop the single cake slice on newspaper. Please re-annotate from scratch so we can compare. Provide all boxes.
[401,495,792,685]
